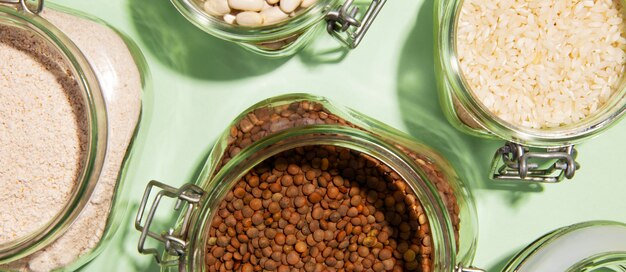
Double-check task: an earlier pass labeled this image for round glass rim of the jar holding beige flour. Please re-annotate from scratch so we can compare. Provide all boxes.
[0,5,107,263]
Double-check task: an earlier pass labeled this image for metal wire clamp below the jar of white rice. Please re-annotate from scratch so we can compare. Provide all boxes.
[491,142,580,183]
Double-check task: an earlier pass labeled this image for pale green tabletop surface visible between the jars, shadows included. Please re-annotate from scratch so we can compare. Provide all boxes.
[47,0,626,271]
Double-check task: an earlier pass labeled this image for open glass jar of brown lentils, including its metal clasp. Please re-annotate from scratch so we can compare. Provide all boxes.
[135,94,477,271]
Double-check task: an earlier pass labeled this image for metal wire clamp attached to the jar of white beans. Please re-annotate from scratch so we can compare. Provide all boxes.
[326,0,387,49]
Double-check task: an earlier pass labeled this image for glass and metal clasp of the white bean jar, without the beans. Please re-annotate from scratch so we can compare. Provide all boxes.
[171,0,386,57]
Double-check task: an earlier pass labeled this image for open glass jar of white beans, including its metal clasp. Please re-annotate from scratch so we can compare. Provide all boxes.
[171,0,386,57]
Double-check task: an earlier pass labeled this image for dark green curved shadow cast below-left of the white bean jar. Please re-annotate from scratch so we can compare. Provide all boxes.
[128,0,289,81]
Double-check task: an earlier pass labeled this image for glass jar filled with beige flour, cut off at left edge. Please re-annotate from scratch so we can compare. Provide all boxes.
[0,0,148,271]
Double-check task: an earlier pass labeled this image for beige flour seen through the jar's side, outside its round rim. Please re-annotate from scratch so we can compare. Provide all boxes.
[0,9,142,271]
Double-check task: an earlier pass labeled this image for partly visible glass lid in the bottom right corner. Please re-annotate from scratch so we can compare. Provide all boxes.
[503,221,626,272]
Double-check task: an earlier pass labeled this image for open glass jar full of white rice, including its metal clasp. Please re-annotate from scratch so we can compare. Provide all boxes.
[435,0,626,182]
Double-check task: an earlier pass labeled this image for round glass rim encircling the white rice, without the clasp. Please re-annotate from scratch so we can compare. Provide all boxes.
[436,0,626,147]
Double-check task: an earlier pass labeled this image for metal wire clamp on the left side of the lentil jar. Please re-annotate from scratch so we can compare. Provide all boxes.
[135,180,204,265]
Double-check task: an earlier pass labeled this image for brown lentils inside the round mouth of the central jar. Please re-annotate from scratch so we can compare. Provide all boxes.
[206,146,431,271]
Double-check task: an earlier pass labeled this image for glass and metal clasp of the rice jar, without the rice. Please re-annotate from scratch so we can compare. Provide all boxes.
[435,0,626,182]
